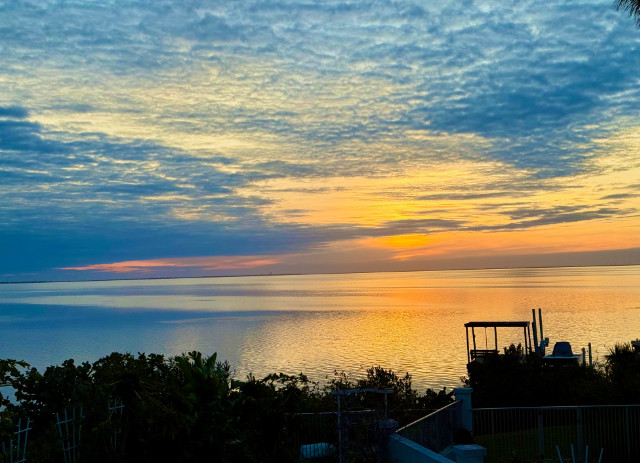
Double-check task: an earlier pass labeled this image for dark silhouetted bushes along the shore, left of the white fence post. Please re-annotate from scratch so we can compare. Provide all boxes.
[0,352,452,463]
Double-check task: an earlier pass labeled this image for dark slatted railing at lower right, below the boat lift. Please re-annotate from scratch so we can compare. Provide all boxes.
[473,405,640,463]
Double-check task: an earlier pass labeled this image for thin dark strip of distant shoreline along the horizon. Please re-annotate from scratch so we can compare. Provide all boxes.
[0,263,640,285]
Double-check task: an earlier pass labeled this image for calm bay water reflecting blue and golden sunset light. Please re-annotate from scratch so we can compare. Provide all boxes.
[0,266,640,388]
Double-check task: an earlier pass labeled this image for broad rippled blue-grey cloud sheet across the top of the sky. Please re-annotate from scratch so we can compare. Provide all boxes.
[4,0,640,176]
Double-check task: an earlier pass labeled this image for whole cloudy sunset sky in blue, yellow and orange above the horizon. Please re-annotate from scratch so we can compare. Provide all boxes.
[0,0,640,281]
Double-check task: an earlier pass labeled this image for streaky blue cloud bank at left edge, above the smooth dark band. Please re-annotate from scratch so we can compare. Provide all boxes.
[0,106,264,228]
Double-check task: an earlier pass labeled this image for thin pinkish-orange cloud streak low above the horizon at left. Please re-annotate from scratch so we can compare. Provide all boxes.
[61,256,280,273]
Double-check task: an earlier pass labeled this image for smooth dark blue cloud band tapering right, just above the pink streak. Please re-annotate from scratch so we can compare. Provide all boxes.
[0,216,318,273]
